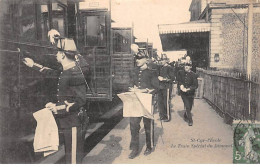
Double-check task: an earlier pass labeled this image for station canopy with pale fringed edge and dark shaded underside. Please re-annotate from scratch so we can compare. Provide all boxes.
[158,20,210,68]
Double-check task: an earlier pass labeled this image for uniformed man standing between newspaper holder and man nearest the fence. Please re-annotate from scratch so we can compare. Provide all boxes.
[158,56,175,122]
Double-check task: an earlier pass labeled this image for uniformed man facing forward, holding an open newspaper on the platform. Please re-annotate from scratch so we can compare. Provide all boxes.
[119,44,159,159]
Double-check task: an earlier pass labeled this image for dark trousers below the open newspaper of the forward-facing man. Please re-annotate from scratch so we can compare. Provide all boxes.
[130,117,152,151]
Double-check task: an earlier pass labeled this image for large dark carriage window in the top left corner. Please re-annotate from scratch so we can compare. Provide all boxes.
[0,0,40,42]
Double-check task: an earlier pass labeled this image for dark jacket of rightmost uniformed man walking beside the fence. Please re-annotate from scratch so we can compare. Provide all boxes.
[178,70,198,96]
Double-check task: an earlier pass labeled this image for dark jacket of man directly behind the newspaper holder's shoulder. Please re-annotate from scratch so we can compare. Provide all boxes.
[159,64,175,89]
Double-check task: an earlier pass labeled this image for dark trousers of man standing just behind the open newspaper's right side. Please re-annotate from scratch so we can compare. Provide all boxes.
[158,89,168,119]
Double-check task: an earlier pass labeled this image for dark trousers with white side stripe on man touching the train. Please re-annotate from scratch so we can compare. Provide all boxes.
[62,127,84,164]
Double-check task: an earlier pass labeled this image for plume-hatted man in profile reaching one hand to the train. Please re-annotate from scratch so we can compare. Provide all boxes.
[24,30,89,163]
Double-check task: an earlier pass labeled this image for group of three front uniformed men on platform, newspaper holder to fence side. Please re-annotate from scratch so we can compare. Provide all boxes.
[123,44,198,159]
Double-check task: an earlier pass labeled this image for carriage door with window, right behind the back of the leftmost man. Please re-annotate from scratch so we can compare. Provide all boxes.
[78,9,112,100]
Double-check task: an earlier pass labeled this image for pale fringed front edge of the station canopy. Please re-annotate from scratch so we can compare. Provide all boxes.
[158,20,210,35]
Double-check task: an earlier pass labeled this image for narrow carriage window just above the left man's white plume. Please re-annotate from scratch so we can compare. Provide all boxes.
[52,3,66,36]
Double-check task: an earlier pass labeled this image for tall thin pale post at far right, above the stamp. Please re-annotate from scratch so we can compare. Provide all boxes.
[247,0,253,116]
